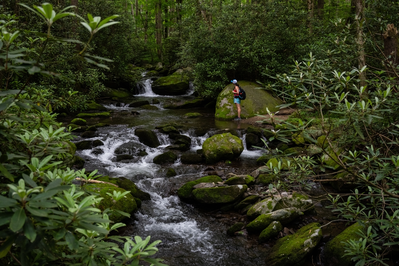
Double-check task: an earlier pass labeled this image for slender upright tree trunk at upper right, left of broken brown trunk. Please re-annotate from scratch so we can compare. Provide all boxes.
[355,0,367,86]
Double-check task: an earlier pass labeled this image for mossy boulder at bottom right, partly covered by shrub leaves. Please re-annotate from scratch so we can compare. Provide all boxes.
[324,223,365,266]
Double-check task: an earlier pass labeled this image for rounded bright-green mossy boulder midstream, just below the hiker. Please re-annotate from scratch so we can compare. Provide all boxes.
[202,133,244,164]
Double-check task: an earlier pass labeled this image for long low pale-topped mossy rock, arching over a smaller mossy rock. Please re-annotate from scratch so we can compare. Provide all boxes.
[247,208,303,232]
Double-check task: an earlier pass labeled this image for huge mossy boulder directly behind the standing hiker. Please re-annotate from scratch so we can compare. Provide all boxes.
[215,81,282,120]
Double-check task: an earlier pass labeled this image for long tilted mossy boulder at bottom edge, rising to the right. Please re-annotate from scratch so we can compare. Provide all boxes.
[266,223,323,266]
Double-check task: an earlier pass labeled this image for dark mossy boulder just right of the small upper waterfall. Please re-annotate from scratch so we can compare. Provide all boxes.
[152,69,190,95]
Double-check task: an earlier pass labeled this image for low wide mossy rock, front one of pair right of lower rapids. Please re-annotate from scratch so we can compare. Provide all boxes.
[192,185,248,204]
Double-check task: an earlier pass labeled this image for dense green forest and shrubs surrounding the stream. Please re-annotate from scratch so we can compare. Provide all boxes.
[0,0,399,265]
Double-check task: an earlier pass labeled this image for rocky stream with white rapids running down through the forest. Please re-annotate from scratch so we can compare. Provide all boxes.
[77,76,267,265]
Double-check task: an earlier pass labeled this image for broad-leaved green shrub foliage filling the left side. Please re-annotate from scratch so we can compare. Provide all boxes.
[0,4,164,265]
